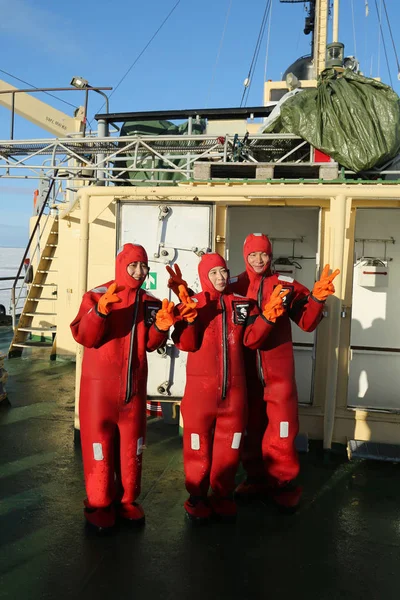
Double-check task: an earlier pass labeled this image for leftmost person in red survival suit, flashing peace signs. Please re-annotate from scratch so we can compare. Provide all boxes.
[71,244,175,530]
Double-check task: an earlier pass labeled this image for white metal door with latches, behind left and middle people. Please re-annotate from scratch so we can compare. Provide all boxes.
[118,202,212,400]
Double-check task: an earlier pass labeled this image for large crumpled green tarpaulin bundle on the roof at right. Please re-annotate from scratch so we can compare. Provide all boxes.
[264,69,400,173]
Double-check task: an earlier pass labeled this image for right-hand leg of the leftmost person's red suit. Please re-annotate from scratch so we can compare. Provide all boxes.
[118,395,146,504]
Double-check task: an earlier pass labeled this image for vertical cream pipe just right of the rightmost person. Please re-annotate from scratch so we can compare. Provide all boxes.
[324,194,351,450]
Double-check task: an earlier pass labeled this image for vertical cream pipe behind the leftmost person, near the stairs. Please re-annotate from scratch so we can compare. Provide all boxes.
[74,190,90,429]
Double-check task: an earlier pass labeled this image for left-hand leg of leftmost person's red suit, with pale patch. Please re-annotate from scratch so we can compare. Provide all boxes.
[79,378,118,508]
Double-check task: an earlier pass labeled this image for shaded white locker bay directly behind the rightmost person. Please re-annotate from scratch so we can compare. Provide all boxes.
[227,206,320,404]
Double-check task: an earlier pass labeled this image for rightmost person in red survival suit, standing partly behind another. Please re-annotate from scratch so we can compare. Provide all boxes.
[168,234,339,511]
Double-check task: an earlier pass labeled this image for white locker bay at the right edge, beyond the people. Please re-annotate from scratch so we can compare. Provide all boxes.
[347,208,400,411]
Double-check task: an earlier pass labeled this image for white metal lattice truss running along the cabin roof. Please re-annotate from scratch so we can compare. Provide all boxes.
[0,133,400,190]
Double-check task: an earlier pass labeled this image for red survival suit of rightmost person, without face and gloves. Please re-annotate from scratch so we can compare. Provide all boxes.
[230,234,324,488]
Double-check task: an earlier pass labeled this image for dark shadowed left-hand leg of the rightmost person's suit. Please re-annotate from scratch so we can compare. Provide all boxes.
[241,379,268,480]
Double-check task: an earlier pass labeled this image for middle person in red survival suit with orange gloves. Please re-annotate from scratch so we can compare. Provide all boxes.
[172,253,282,520]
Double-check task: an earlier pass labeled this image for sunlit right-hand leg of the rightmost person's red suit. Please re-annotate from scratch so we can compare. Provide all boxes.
[262,374,300,483]
